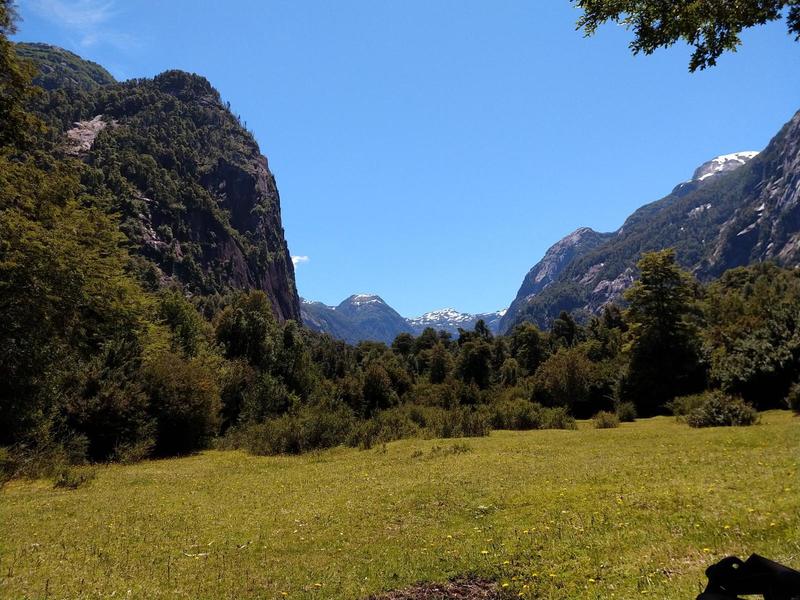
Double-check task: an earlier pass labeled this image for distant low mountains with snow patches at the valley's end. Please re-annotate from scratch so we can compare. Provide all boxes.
[300,294,505,344]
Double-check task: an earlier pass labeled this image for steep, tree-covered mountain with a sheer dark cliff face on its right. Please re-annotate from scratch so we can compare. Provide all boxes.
[17,44,300,320]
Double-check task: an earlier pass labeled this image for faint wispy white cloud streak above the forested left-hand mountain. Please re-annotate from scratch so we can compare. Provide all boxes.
[29,0,138,50]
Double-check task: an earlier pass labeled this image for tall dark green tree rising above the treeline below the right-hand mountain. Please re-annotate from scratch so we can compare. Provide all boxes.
[623,249,705,416]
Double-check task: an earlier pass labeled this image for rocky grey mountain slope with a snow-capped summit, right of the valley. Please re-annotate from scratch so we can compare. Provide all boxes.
[501,113,800,331]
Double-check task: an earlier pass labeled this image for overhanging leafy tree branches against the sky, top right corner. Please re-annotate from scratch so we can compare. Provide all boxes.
[572,0,800,72]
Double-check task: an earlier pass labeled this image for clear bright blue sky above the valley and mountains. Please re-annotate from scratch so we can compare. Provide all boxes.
[16,0,800,316]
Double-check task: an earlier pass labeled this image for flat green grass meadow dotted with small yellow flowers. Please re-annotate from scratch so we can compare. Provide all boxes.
[0,412,800,599]
